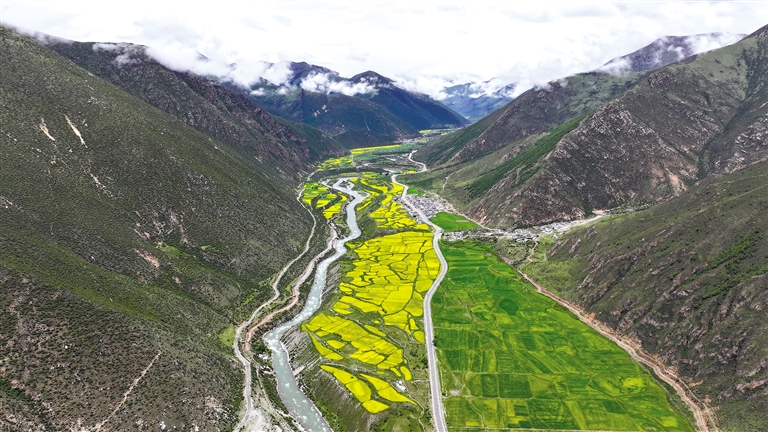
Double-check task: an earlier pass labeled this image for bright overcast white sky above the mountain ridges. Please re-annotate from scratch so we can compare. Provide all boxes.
[0,0,768,97]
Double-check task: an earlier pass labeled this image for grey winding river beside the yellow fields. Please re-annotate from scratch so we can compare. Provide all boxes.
[264,179,365,432]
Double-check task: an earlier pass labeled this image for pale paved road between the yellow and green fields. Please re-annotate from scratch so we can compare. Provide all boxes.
[392,152,448,432]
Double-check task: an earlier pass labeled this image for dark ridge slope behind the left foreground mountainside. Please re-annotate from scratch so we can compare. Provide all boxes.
[48,39,343,176]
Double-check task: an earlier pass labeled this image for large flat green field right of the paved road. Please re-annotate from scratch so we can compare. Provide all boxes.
[432,242,693,431]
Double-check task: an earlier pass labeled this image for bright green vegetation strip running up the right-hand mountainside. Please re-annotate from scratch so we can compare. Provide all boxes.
[467,113,588,196]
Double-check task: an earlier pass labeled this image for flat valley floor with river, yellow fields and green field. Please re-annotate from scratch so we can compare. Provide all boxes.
[234,145,704,432]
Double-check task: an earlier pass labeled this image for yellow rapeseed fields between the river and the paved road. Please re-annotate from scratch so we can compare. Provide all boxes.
[302,175,440,413]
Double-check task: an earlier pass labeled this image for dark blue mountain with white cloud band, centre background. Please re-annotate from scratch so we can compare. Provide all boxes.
[241,63,469,147]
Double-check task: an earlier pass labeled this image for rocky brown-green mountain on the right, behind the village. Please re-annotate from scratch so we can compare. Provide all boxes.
[404,28,768,226]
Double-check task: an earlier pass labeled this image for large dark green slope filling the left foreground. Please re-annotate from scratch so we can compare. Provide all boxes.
[0,28,311,430]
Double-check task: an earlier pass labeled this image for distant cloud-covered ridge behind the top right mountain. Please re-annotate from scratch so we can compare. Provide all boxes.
[597,33,747,73]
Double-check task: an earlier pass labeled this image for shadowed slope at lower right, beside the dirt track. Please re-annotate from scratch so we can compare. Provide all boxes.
[523,159,768,432]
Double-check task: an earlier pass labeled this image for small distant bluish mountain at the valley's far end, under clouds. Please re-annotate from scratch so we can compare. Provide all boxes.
[440,81,516,123]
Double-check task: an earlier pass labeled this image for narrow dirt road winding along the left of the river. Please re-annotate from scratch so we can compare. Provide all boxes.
[232,193,317,432]
